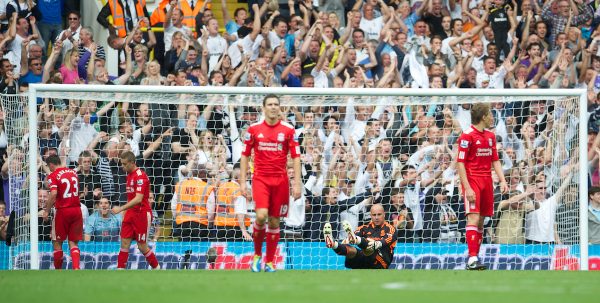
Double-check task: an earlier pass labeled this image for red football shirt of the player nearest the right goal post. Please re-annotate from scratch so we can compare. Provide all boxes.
[458,126,498,177]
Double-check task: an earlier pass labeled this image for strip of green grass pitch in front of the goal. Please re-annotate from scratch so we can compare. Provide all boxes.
[0,270,600,303]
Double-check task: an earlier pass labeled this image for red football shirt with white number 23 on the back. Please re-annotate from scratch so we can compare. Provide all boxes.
[46,167,81,209]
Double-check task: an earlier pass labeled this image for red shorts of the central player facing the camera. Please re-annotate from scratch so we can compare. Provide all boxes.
[252,175,290,217]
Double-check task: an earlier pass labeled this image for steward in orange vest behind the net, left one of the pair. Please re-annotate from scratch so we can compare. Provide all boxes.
[171,165,215,241]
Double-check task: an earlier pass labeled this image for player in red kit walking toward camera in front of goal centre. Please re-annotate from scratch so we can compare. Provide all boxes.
[240,95,302,272]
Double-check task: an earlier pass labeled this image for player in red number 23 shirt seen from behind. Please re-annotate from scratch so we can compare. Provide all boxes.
[42,155,83,270]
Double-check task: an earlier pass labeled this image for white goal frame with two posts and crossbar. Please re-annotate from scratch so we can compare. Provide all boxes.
[19,84,588,270]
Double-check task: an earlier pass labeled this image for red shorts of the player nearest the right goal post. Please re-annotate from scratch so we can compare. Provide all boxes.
[461,176,494,217]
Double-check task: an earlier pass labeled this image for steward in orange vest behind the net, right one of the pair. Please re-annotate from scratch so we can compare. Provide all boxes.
[214,163,250,240]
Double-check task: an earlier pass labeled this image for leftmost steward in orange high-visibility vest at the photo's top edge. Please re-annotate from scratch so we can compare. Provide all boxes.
[96,0,150,38]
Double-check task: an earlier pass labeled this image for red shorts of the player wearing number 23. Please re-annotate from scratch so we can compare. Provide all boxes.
[52,207,83,242]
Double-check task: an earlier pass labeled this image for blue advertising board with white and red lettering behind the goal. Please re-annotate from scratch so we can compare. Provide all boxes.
[0,242,600,270]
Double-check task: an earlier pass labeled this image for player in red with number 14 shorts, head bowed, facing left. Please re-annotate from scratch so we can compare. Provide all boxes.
[112,151,160,269]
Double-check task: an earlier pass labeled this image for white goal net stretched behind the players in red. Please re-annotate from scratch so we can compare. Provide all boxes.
[2,85,589,269]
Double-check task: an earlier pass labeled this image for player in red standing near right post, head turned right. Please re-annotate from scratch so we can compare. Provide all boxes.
[456,103,508,270]
